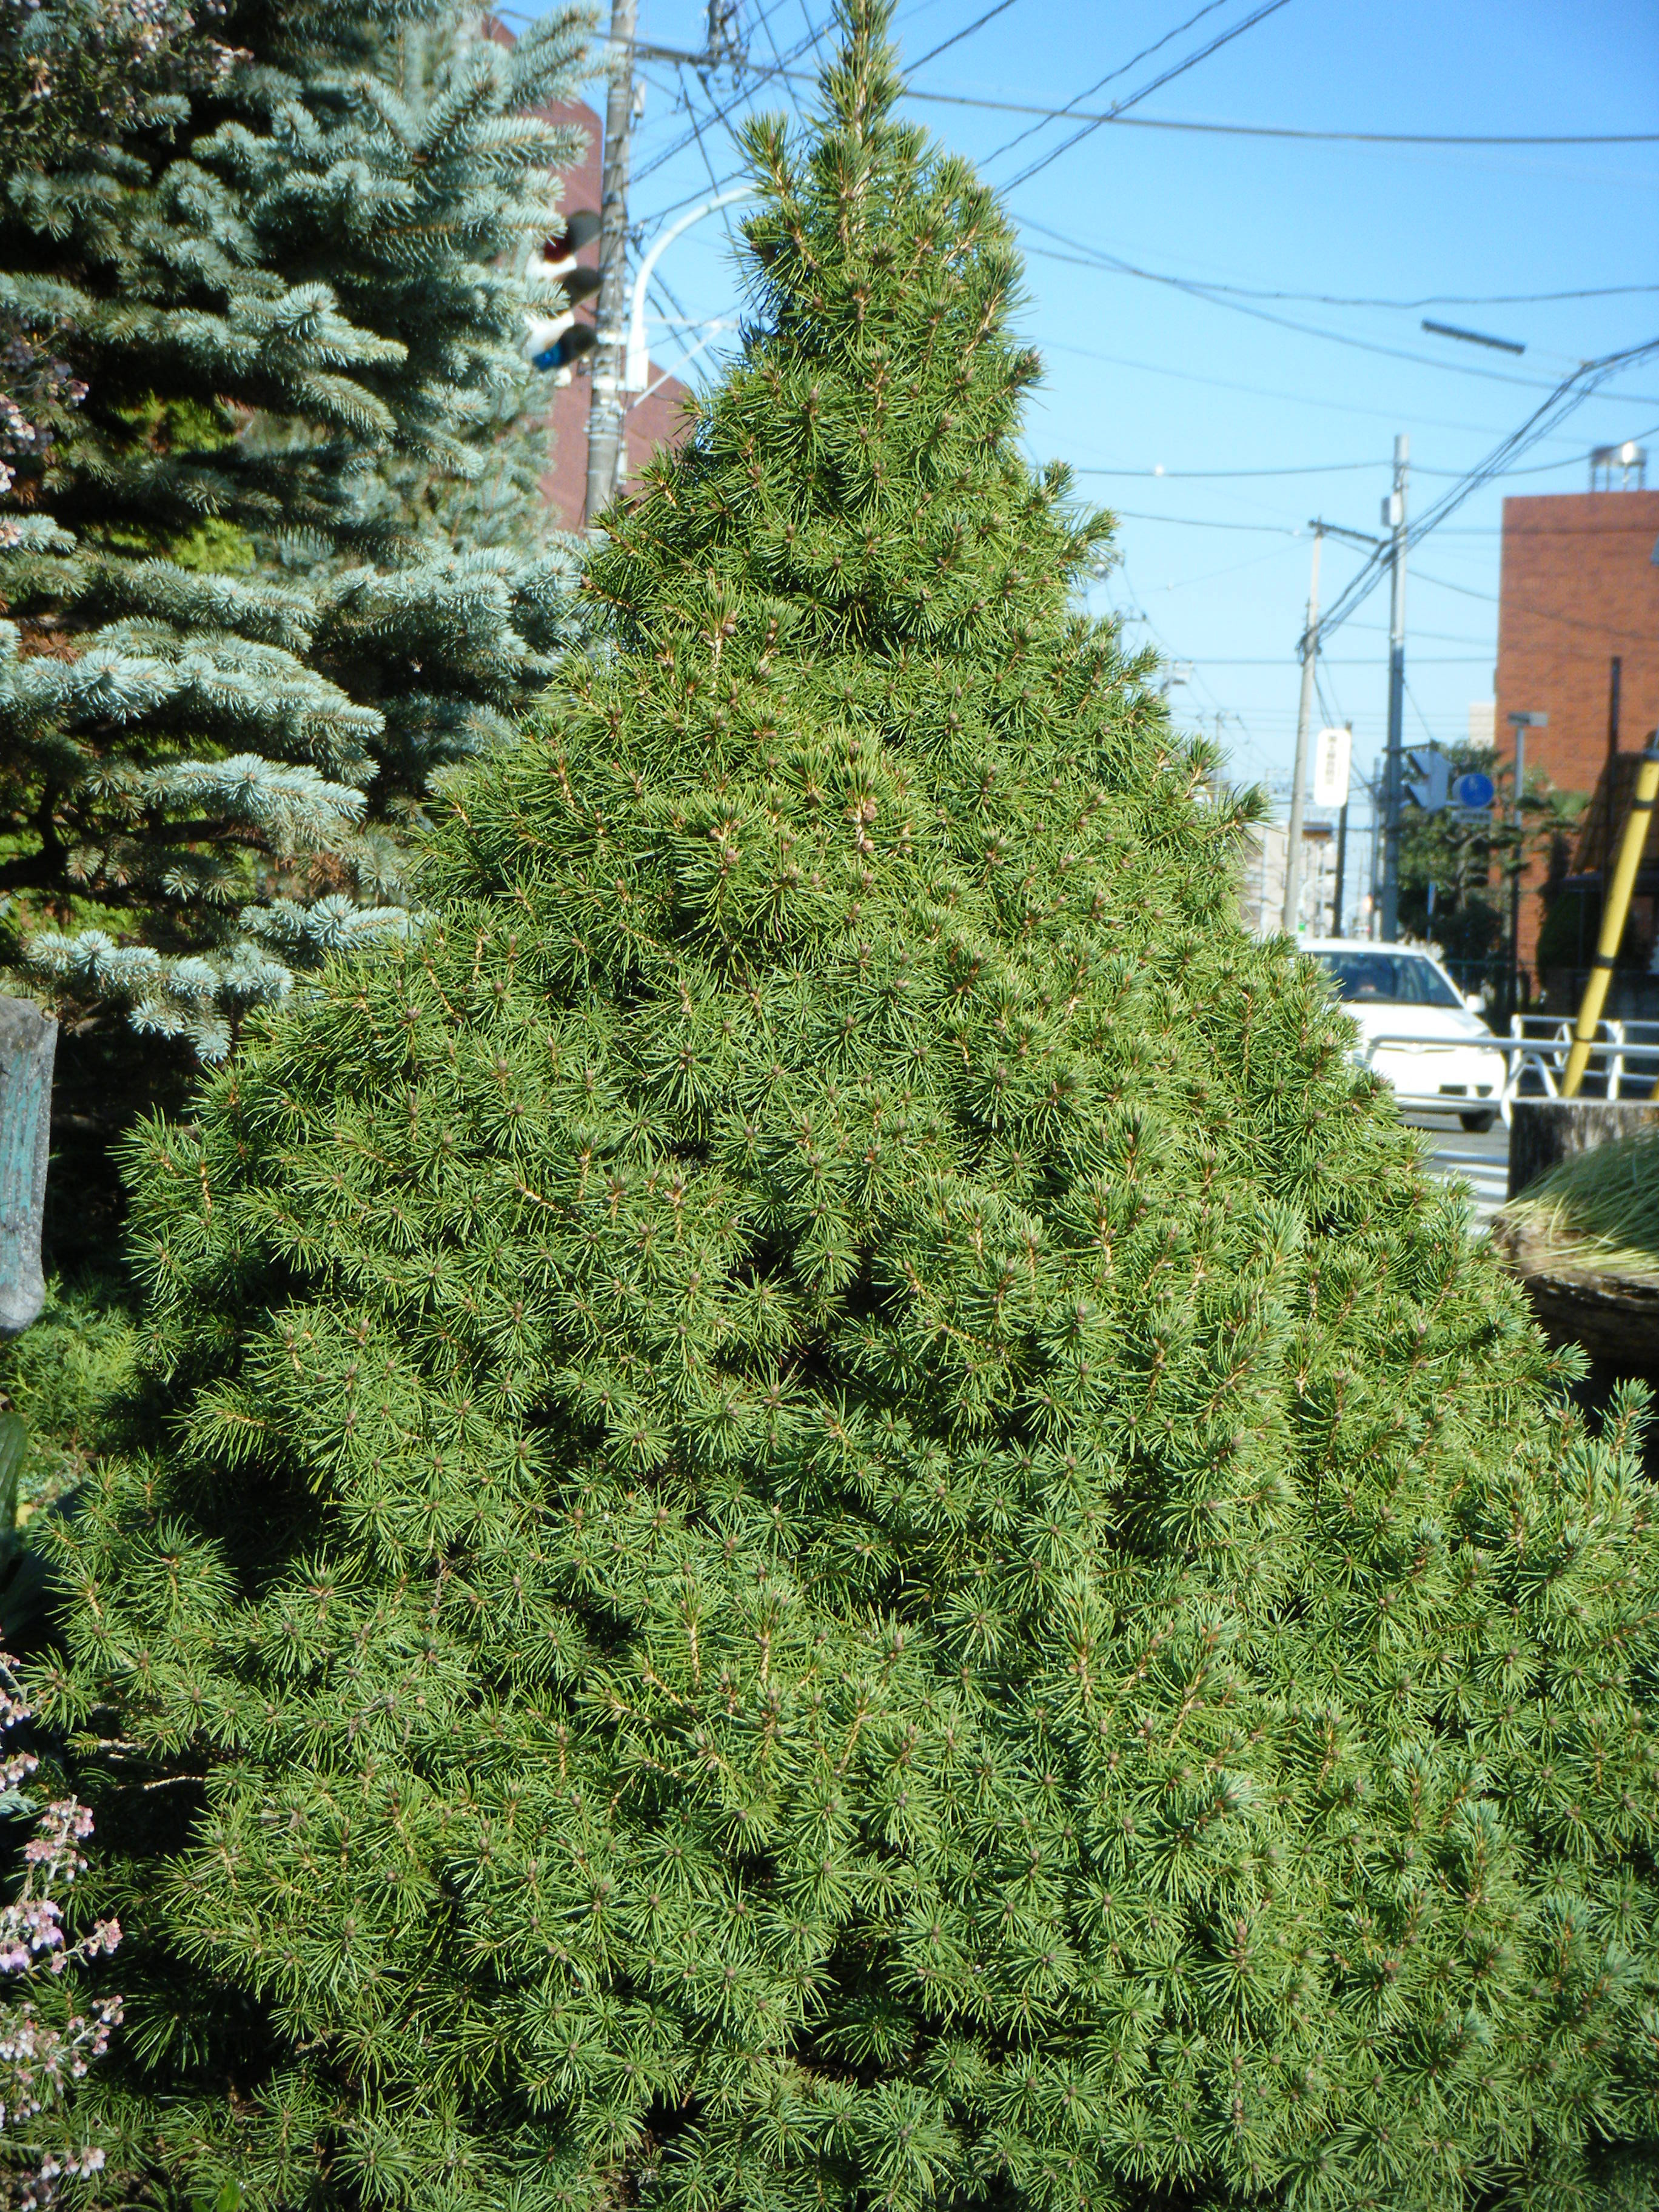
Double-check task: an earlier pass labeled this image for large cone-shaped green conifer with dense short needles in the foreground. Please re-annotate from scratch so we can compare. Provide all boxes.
[38,0,1659,2212]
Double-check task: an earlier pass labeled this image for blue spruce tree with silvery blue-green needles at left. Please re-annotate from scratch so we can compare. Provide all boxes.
[0,0,586,1062]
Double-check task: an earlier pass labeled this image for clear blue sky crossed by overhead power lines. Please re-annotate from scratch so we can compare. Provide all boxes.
[509,0,1659,823]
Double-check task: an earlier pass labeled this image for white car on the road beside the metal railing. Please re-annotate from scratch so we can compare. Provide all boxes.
[1301,938,1506,1130]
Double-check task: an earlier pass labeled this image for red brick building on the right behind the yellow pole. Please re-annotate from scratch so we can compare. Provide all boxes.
[1498,491,1659,965]
